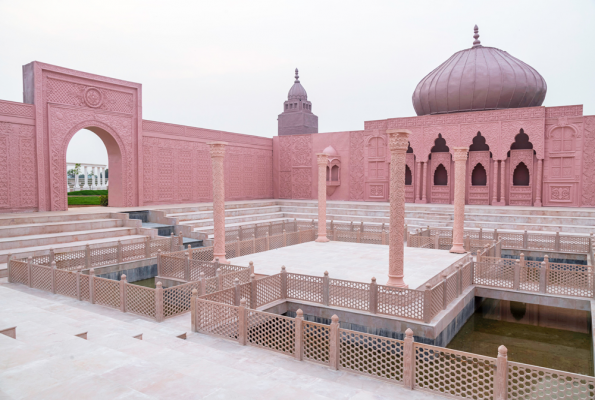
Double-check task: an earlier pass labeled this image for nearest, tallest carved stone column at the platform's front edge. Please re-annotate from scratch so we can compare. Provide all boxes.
[386,129,411,288]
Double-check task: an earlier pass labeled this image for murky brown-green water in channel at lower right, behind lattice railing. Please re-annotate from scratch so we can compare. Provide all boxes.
[446,297,593,376]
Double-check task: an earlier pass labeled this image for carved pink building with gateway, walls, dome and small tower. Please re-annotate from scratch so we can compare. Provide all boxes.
[0,29,595,212]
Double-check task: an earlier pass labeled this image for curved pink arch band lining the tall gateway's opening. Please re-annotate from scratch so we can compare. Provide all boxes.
[64,122,126,207]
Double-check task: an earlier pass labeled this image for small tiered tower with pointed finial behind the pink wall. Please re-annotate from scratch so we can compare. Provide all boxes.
[277,68,318,136]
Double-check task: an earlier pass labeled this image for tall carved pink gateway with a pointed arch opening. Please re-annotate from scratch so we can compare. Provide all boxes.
[23,61,142,211]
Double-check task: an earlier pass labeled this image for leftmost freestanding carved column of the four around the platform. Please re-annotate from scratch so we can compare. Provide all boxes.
[207,142,229,264]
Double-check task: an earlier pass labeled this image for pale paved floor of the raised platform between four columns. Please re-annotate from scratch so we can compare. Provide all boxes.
[230,241,464,289]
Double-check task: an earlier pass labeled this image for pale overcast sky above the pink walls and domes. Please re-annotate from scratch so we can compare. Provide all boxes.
[0,0,595,163]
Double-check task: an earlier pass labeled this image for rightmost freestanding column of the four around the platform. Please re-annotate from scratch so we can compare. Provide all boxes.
[450,147,469,253]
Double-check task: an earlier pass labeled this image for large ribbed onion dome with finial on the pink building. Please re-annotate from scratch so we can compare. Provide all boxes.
[413,25,547,115]
